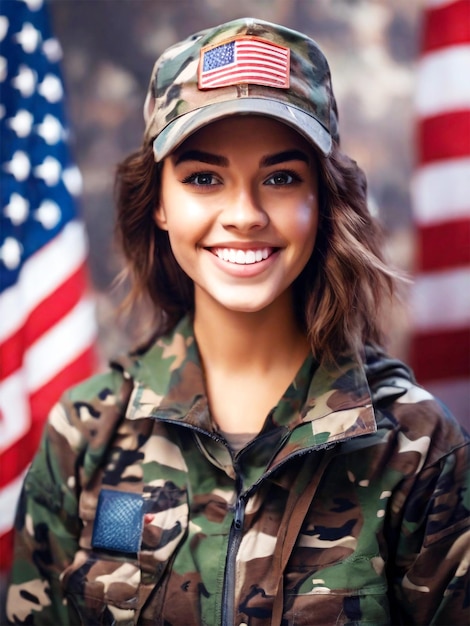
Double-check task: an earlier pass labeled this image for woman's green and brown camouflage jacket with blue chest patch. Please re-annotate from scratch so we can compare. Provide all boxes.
[7,320,469,626]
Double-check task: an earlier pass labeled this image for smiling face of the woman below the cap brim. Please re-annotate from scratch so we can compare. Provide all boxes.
[156,116,318,315]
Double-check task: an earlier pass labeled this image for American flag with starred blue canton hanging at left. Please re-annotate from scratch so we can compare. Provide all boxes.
[0,0,96,571]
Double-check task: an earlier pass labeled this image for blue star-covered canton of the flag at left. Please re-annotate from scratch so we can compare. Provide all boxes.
[0,0,81,291]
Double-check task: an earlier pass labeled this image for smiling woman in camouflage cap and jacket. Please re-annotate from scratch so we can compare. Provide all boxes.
[8,19,469,626]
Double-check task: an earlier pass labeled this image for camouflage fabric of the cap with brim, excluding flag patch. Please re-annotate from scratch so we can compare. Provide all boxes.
[144,18,339,161]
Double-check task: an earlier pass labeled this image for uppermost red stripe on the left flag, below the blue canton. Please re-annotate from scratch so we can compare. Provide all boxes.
[0,264,86,379]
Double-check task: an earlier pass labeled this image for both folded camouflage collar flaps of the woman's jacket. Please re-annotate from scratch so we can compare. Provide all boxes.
[120,318,376,450]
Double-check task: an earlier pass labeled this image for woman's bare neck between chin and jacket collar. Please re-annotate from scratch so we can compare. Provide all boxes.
[194,293,309,433]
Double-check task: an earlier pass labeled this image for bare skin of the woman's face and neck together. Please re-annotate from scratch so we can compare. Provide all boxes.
[155,115,318,432]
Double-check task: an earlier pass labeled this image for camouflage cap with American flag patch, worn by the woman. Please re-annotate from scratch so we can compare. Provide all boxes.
[144,18,339,162]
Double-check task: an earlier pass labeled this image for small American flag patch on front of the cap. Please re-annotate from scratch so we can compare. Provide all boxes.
[199,36,290,89]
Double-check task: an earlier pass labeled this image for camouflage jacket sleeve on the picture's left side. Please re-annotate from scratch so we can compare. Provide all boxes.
[6,404,81,626]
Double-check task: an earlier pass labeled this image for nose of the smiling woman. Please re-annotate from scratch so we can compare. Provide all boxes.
[222,187,269,232]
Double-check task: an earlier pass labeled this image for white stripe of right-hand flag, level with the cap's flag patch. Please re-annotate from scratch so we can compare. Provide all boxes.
[415,44,470,117]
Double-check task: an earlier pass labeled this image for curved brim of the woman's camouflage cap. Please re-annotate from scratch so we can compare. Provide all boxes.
[153,97,332,163]
